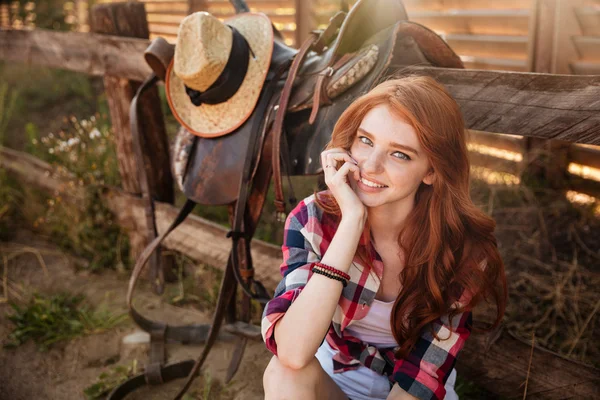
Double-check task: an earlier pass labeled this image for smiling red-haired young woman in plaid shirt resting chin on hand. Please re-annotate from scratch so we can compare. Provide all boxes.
[262,77,506,400]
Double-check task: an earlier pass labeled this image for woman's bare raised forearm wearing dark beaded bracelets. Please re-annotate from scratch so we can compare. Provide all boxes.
[274,215,364,369]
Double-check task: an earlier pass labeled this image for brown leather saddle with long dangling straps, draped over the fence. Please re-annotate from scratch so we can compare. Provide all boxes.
[109,0,463,400]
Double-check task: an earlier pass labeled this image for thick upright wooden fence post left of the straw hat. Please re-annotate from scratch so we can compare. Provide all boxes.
[90,2,174,282]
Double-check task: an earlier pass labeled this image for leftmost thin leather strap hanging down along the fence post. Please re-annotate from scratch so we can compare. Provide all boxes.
[129,73,164,294]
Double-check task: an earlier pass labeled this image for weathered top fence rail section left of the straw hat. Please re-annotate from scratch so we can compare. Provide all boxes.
[0,29,150,82]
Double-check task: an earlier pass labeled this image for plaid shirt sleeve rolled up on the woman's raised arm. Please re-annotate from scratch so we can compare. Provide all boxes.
[261,202,321,355]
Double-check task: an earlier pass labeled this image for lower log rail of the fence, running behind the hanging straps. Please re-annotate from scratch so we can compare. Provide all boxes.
[0,147,600,399]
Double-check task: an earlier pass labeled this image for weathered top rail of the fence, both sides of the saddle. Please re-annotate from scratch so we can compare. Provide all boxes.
[0,30,600,145]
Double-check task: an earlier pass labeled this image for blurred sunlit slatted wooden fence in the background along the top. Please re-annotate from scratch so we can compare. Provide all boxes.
[0,0,600,75]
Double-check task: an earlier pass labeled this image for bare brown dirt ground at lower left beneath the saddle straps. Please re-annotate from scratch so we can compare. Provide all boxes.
[0,232,271,400]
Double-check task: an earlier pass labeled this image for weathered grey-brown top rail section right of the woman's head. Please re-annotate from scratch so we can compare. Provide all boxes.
[406,67,600,145]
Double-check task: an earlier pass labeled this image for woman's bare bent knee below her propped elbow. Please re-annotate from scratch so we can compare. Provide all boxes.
[263,356,348,400]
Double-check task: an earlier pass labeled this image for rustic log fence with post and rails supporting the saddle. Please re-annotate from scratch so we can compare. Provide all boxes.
[0,2,600,398]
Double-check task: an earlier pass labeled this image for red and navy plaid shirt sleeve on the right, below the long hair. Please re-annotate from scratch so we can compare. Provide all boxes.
[393,311,472,400]
